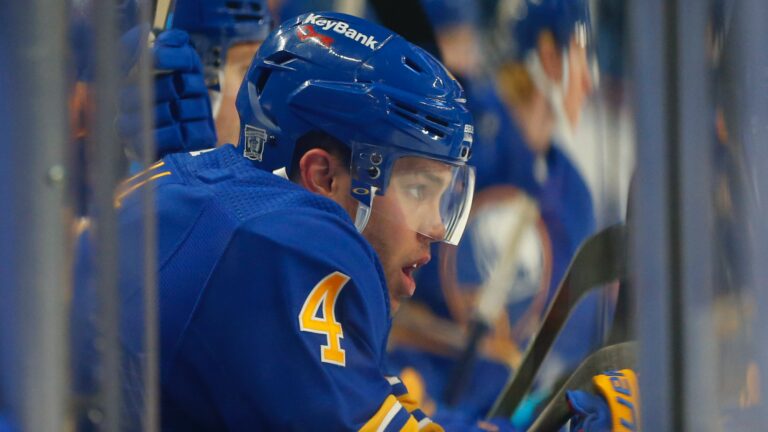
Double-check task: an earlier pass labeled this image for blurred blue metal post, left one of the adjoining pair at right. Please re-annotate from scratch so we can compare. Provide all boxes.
[629,0,682,431]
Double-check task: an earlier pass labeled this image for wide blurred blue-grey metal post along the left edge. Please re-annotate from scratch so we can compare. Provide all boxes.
[0,0,71,431]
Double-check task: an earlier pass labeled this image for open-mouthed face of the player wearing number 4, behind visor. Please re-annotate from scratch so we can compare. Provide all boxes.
[363,157,452,313]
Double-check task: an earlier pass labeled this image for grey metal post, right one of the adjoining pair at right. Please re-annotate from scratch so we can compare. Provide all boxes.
[670,0,718,430]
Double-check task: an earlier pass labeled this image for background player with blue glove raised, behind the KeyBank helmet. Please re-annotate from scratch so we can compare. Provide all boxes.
[118,0,272,158]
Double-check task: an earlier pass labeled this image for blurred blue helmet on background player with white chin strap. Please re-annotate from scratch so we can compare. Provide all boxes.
[502,0,592,59]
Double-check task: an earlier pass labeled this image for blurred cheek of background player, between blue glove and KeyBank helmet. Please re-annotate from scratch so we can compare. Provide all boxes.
[216,42,261,145]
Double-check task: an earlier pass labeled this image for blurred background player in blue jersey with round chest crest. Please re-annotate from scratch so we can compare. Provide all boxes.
[391,0,602,424]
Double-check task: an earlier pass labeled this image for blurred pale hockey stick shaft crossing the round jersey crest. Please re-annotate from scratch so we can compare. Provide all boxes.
[443,195,539,405]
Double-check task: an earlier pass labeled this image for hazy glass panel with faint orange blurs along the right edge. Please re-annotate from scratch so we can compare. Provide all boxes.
[709,0,768,431]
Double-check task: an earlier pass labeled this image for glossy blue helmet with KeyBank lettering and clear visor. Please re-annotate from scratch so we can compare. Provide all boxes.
[237,12,474,243]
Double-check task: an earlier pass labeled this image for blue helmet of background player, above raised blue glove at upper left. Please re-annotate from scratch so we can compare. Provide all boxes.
[172,0,272,85]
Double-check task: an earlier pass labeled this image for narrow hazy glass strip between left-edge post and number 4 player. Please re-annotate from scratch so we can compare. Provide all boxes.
[68,0,157,430]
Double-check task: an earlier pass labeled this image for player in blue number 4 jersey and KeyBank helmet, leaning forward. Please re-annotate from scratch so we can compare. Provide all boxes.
[73,13,474,431]
